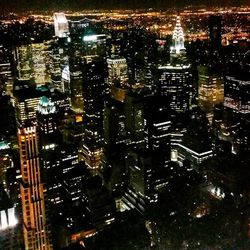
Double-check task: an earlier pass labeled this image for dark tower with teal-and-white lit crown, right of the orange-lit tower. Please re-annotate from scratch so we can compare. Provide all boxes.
[37,96,62,209]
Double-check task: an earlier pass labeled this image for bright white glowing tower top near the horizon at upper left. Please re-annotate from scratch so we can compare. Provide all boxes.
[54,13,69,38]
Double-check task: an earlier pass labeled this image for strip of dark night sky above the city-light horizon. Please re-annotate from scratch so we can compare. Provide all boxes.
[0,0,250,10]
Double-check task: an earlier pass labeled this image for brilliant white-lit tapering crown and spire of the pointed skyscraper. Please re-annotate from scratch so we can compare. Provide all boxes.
[171,16,185,54]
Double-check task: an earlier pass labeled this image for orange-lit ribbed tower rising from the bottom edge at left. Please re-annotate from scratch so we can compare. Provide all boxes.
[18,124,52,250]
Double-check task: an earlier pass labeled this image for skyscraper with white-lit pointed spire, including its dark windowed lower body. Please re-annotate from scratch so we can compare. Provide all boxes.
[156,17,193,112]
